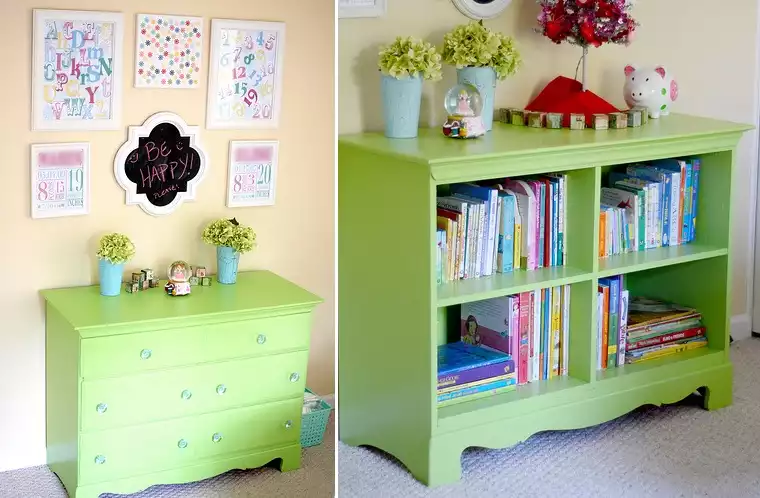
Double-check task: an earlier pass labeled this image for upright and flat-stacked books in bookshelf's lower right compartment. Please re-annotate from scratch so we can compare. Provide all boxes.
[597,275,707,370]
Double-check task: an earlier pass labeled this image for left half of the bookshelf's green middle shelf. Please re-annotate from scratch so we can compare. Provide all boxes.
[437,266,593,308]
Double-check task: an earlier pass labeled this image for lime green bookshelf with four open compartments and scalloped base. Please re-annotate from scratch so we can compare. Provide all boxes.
[338,115,751,486]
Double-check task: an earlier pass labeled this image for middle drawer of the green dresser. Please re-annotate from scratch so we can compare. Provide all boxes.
[81,351,309,431]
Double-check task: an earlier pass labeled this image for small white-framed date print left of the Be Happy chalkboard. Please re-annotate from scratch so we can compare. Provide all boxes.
[29,142,90,219]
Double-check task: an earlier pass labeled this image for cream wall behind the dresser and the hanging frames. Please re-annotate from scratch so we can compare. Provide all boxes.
[0,0,335,471]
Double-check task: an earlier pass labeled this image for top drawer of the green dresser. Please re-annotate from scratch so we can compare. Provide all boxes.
[80,313,311,379]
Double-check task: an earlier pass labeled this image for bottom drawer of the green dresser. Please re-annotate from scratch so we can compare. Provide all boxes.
[79,396,303,485]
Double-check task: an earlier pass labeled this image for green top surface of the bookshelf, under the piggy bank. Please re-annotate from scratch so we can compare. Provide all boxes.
[339,114,753,163]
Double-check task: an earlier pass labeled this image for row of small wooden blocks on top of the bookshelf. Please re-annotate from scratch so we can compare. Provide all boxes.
[499,108,649,130]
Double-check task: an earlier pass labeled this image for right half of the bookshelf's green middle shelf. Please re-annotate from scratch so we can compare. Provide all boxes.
[597,243,728,278]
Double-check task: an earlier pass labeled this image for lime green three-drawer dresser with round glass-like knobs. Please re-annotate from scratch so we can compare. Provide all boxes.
[42,271,321,498]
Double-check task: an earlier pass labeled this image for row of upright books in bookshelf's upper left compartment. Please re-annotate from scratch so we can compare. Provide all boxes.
[436,174,567,283]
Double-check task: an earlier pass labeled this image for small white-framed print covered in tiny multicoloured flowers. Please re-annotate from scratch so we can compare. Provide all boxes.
[133,14,207,90]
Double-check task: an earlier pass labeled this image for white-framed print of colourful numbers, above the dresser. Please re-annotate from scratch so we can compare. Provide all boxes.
[206,19,285,129]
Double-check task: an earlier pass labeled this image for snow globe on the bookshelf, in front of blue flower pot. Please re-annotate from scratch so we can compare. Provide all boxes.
[443,84,486,138]
